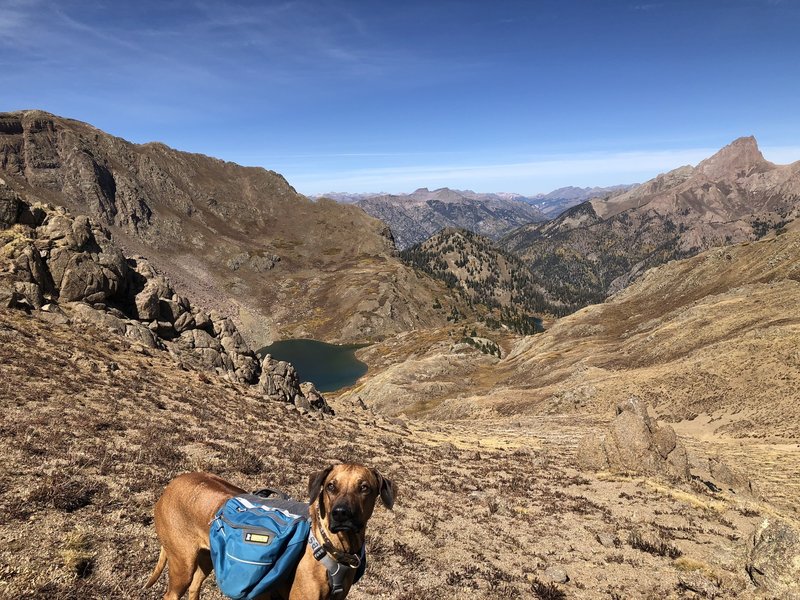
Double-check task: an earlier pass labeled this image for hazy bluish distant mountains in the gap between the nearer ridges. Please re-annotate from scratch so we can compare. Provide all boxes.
[322,188,545,250]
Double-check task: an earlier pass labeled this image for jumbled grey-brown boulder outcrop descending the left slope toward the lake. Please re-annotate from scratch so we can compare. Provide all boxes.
[0,195,330,412]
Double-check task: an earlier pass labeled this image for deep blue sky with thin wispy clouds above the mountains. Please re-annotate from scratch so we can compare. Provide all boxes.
[0,0,800,194]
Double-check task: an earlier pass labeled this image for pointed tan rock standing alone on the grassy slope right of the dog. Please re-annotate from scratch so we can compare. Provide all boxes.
[578,397,690,480]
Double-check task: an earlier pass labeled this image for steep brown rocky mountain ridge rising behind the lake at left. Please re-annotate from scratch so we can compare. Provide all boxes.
[0,111,456,346]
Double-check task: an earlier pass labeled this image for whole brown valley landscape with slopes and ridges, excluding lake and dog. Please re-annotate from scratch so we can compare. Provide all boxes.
[0,111,800,600]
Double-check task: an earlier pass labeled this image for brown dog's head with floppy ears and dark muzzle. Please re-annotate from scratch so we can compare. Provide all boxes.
[308,465,394,533]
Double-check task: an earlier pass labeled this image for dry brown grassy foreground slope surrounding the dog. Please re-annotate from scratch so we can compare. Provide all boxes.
[0,310,791,600]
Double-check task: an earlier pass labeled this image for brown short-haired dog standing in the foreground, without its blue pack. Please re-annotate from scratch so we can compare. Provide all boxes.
[145,464,394,600]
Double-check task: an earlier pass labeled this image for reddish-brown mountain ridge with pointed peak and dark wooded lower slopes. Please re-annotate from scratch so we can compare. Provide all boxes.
[500,138,800,305]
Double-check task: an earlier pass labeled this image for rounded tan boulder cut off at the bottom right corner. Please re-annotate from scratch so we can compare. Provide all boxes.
[747,517,800,600]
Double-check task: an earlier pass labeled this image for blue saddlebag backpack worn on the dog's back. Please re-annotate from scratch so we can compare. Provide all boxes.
[209,494,311,600]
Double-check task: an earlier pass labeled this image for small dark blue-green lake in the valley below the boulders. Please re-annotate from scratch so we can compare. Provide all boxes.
[258,340,367,392]
